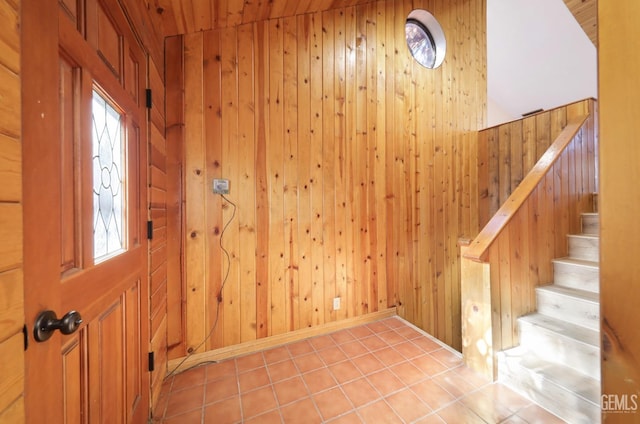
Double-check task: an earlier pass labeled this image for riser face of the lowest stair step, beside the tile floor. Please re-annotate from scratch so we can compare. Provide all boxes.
[498,355,600,424]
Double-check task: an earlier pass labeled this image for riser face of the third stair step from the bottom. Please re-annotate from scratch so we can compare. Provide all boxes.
[536,289,600,330]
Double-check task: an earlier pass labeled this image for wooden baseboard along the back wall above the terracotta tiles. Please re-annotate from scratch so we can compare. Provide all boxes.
[167,308,397,375]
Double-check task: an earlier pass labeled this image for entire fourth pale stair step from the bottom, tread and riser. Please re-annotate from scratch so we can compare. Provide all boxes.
[552,258,600,293]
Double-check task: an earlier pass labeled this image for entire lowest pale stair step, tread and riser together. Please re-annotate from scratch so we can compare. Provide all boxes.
[498,346,600,424]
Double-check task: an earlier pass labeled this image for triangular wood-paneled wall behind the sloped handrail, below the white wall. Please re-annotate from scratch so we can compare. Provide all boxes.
[478,99,597,227]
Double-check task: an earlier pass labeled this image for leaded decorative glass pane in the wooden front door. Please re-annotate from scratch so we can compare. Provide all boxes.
[92,90,126,262]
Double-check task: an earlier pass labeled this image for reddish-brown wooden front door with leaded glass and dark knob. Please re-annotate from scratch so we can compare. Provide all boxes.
[22,0,149,423]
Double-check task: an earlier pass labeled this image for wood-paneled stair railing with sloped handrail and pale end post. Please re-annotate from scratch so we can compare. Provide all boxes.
[461,101,597,379]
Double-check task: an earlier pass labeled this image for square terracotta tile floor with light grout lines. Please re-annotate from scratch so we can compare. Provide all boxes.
[154,317,563,424]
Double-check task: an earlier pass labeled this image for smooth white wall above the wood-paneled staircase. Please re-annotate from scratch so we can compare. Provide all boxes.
[487,0,598,126]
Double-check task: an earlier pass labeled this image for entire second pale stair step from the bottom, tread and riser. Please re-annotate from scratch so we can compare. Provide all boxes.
[518,313,600,380]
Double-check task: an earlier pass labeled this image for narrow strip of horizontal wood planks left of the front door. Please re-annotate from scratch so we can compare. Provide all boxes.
[0,0,24,423]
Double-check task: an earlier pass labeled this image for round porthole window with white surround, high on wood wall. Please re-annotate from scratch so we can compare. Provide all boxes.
[405,9,447,69]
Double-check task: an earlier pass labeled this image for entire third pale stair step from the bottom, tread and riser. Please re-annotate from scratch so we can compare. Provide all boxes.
[536,284,600,331]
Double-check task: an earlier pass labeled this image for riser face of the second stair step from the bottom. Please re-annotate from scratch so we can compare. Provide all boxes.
[519,321,600,380]
